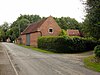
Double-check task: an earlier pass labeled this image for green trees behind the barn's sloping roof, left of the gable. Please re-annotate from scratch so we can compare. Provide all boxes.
[7,15,41,41]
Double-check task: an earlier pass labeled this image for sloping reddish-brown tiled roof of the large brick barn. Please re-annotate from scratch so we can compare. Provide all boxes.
[21,18,47,34]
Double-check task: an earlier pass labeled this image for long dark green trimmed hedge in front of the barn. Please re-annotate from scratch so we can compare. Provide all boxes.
[38,36,97,53]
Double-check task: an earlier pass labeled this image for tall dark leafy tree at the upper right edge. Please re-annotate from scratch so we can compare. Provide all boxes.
[83,0,100,39]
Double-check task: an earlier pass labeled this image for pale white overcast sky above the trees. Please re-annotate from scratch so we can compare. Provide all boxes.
[0,0,84,24]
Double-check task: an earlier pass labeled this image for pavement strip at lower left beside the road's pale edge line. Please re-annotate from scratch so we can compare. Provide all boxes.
[0,43,16,75]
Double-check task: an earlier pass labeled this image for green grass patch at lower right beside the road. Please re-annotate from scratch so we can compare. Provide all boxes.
[84,56,100,72]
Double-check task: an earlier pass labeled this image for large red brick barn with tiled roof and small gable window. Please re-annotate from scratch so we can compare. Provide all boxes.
[21,16,61,47]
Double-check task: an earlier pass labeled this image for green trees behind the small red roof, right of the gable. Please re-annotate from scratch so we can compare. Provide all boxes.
[54,17,80,30]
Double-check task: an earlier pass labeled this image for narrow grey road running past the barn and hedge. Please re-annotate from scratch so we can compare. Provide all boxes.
[2,43,100,75]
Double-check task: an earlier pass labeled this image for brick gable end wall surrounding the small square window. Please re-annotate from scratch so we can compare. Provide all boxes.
[40,17,61,36]
